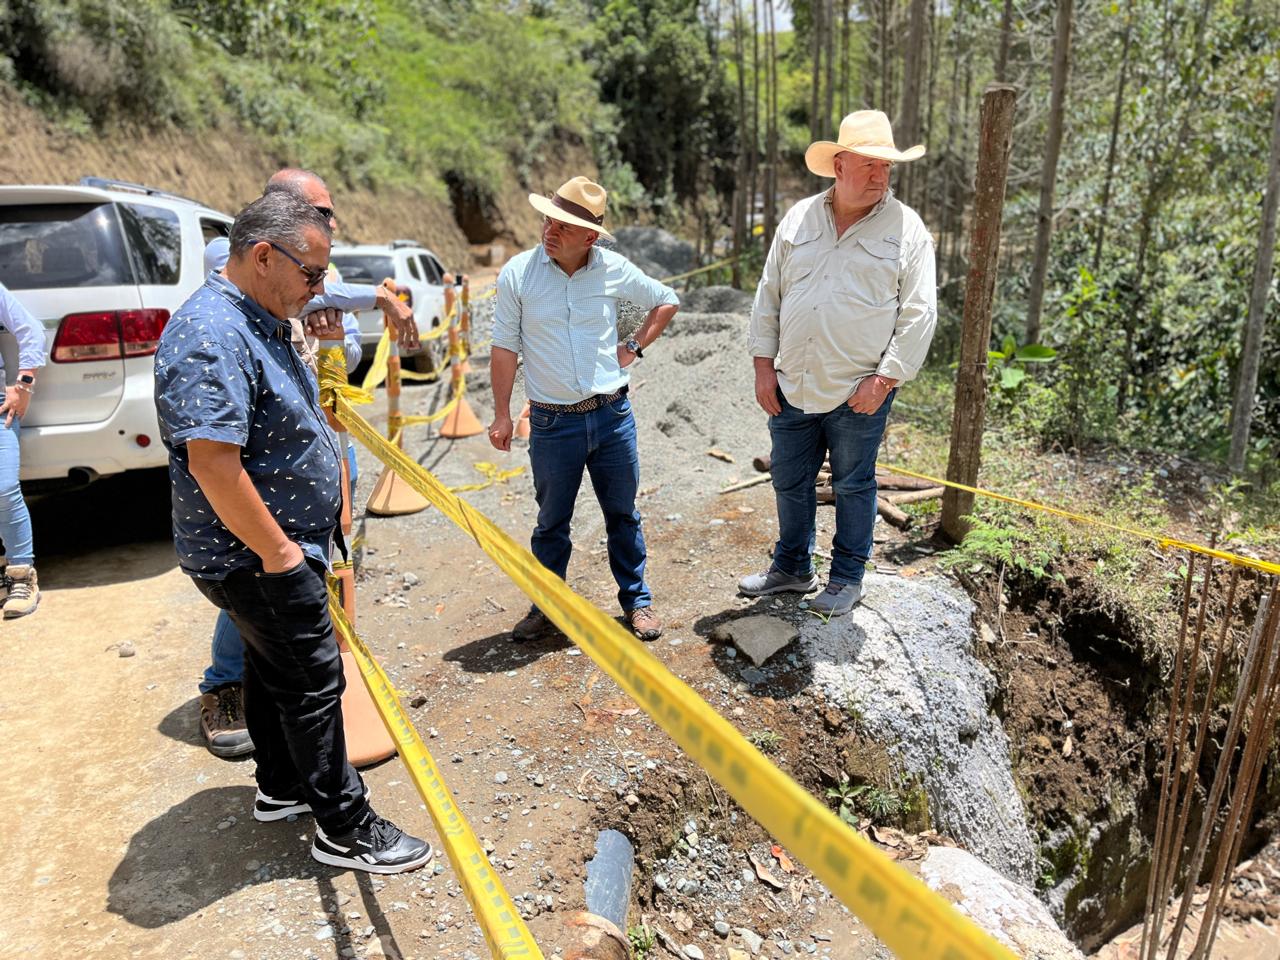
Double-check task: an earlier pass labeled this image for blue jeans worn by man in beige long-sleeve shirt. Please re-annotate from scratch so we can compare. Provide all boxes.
[769,390,897,584]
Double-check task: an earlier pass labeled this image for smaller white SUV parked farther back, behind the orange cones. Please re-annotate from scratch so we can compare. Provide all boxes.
[329,241,445,372]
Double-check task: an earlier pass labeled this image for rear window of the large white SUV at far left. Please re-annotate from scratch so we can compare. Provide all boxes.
[0,204,133,291]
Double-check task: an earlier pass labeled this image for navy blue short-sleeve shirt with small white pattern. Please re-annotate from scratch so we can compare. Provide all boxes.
[155,274,342,580]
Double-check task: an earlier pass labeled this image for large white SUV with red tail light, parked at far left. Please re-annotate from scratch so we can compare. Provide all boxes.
[0,177,232,488]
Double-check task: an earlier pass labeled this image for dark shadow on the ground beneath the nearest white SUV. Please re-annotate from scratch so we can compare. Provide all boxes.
[31,468,178,590]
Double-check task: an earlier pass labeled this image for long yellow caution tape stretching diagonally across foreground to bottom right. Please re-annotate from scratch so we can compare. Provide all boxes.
[323,371,1014,960]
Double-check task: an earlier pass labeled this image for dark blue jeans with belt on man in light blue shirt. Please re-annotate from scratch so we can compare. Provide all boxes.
[529,397,653,613]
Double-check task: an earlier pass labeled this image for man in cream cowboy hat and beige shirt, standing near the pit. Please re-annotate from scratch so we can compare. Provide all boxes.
[737,110,937,616]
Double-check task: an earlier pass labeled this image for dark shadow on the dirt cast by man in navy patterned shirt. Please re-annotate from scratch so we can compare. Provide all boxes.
[106,787,320,929]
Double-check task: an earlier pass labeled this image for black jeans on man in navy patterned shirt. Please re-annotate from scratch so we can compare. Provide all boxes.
[196,561,369,835]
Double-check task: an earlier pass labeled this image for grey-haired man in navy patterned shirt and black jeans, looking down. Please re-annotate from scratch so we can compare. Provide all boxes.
[155,192,431,873]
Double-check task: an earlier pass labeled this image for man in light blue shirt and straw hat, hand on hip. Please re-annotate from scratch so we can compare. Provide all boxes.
[489,177,680,640]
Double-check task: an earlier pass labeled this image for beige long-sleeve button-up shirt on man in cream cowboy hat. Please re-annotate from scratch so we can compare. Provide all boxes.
[748,189,938,413]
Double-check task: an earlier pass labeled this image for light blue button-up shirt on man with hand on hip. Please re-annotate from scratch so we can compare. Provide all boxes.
[493,244,680,403]
